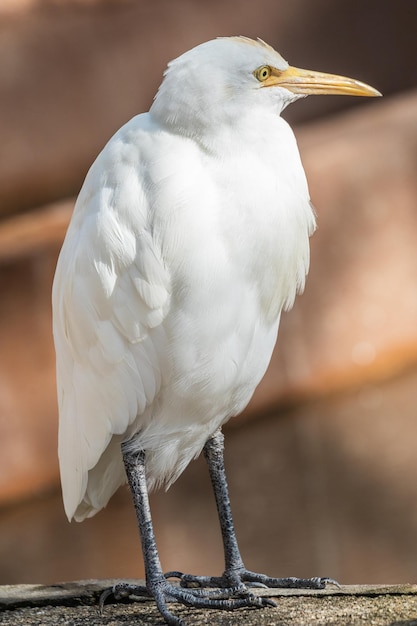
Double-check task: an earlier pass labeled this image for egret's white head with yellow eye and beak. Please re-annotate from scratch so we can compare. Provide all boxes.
[151,37,381,143]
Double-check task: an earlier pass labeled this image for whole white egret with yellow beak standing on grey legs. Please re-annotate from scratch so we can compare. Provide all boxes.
[53,37,380,624]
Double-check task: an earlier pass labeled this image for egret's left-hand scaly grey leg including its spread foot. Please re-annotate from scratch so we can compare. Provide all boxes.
[100,444,270,626]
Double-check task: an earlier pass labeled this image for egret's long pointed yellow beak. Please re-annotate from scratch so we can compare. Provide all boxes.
[263,66,382,97]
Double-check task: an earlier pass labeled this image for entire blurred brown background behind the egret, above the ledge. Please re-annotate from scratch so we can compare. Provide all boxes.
[0,0,417,584]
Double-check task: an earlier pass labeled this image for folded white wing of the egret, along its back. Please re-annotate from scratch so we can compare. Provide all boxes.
[53,120,170,518]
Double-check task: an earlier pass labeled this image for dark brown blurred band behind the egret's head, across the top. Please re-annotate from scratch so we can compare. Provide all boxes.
[0,0,417,214]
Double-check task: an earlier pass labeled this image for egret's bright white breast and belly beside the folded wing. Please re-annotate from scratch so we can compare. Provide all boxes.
[148,132,312,416]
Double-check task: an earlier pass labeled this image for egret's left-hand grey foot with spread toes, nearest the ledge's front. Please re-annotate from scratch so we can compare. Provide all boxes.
[99,572,275,626]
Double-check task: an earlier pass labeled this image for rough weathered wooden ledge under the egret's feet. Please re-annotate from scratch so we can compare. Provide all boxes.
[0,580,417,626]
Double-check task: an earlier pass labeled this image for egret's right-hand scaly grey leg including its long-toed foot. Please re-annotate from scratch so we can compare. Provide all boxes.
[171,429,338,589]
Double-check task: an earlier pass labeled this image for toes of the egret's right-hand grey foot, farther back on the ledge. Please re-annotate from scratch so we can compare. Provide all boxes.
[165,568,340,589]
